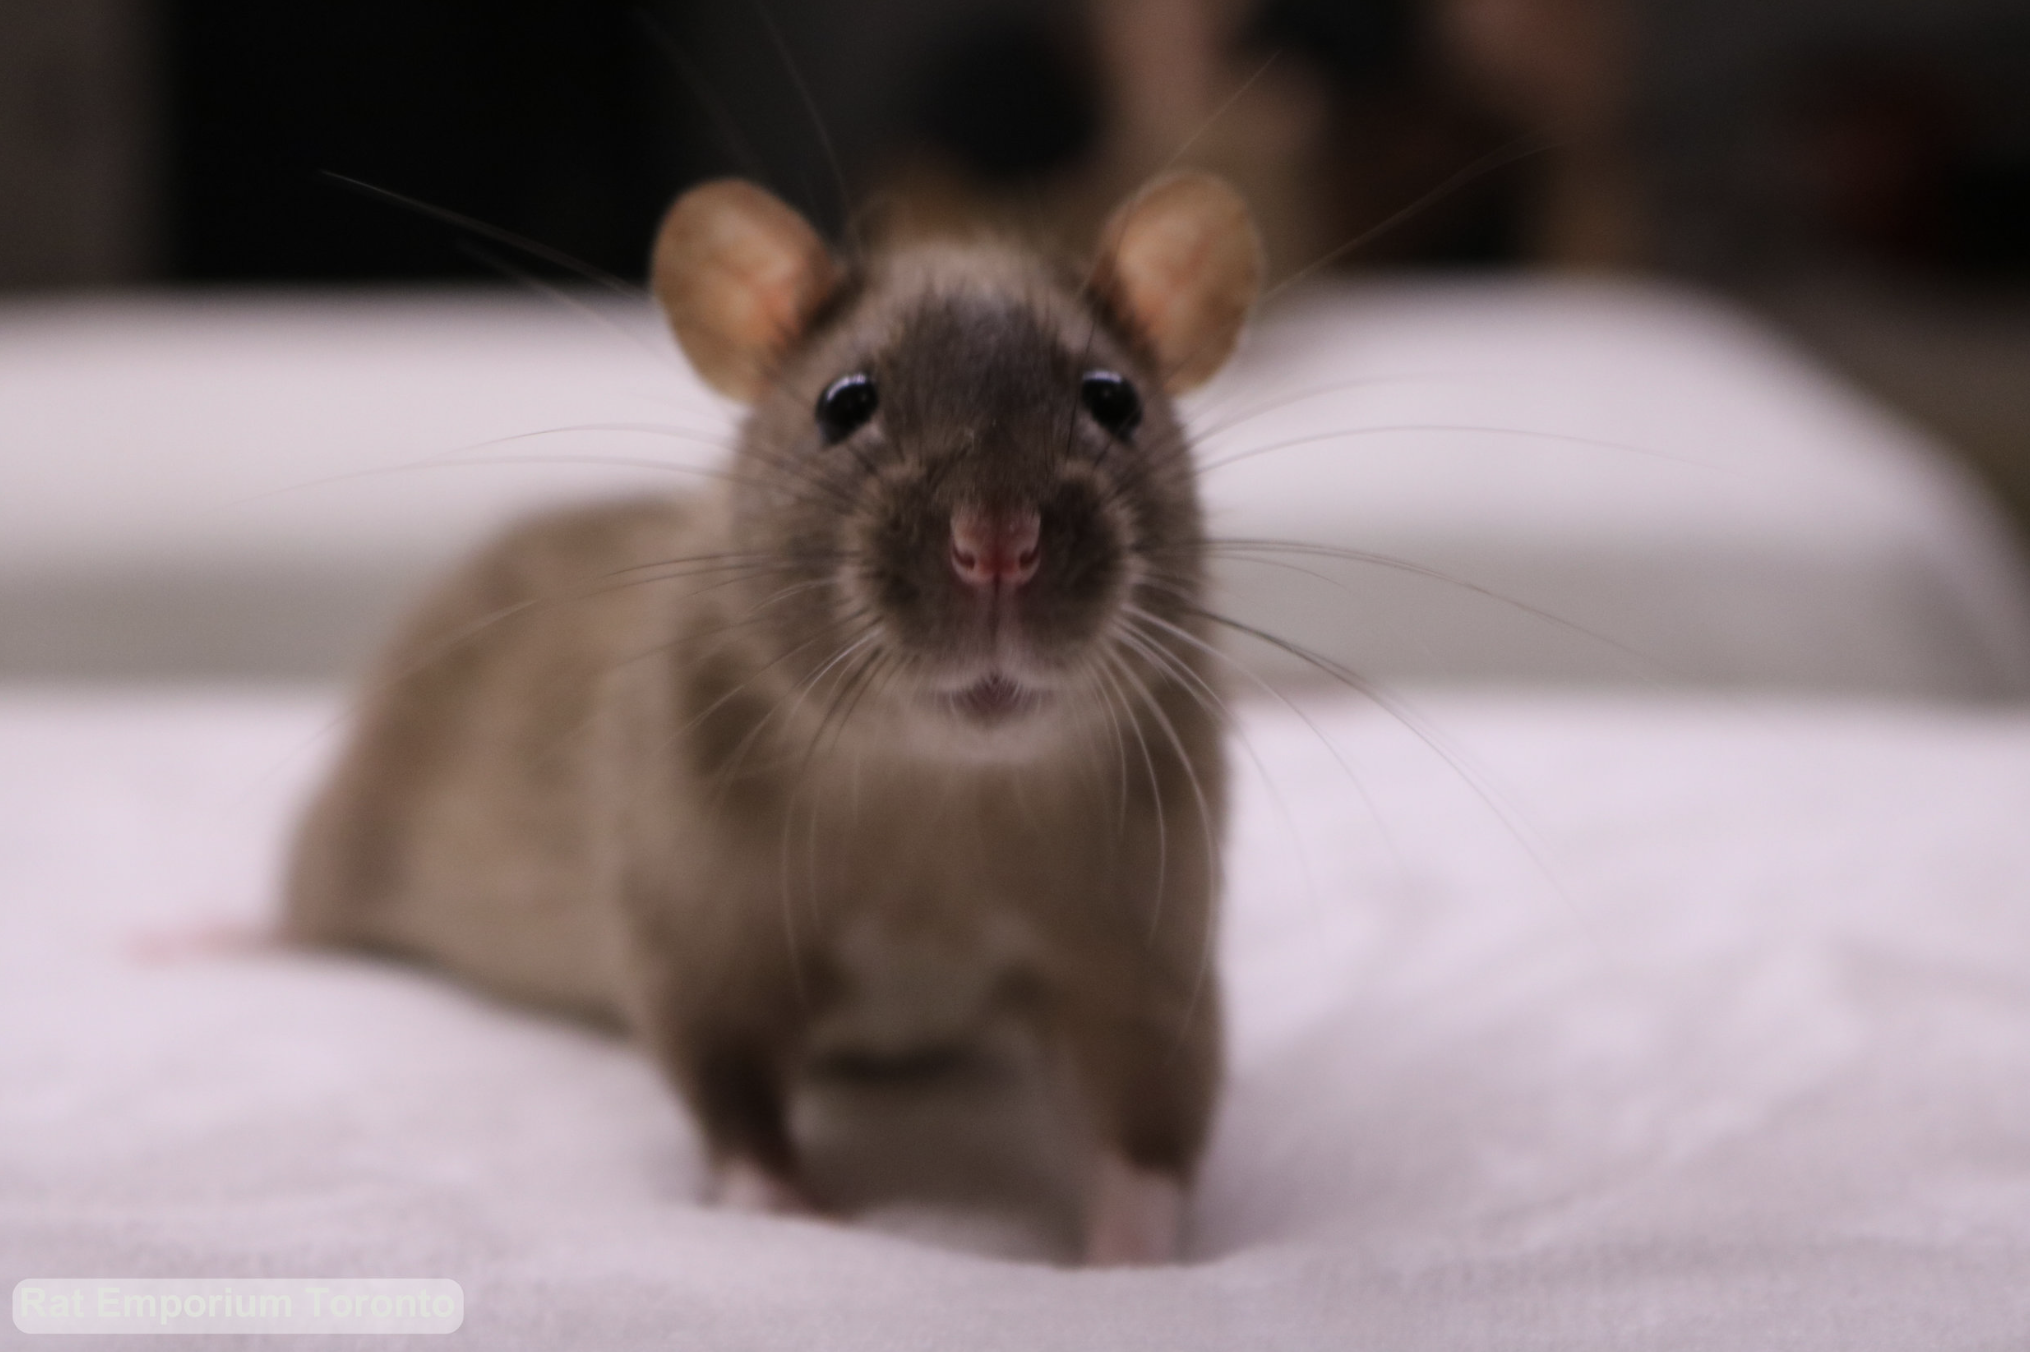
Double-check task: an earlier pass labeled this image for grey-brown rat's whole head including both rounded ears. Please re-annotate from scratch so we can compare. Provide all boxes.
[654,175,1261,747]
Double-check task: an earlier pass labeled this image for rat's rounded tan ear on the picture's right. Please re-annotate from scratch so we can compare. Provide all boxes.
[1092,171,1263,394]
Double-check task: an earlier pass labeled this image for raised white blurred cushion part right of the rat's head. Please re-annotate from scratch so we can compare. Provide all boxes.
[1198,280,2030,696]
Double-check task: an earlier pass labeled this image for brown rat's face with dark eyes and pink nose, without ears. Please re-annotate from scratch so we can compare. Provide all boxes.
[733,252,1202,741]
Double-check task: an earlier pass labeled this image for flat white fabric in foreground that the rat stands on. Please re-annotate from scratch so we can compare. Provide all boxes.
[0,692,2030,1352]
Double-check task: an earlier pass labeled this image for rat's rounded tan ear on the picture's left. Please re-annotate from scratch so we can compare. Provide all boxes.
[650,179,838,402]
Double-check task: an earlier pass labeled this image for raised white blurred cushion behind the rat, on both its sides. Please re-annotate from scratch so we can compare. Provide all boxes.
[0,280,2030,696]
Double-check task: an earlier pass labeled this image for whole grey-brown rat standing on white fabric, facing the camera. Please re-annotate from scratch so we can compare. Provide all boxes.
[284,173,1263,1265]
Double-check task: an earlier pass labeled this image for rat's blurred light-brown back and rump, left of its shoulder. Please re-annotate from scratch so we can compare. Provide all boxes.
[284,489,708,1019]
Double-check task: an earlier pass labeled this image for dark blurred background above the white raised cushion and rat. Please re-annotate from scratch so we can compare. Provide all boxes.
[0,0,2030,508]
